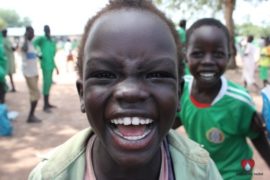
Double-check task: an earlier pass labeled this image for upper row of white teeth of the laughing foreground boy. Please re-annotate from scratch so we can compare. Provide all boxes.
[111,117,153,126]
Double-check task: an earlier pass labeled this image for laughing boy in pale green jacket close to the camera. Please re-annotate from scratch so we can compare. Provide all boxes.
[30,0,221,180]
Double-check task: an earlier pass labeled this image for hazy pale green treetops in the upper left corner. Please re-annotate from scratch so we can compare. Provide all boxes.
[0,9,31,27]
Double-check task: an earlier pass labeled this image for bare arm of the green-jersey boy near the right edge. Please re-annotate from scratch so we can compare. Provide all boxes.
[251,113,270,167]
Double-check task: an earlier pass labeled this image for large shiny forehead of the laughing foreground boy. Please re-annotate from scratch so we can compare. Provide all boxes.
[84,9,176,59]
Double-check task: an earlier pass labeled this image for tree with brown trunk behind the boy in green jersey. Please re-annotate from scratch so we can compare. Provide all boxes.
[154,0,263,68]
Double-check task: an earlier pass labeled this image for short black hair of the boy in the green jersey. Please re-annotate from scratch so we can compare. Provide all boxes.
[187,18,230,53]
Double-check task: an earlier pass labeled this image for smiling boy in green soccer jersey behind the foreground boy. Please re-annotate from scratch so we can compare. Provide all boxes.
[174,18,270,179]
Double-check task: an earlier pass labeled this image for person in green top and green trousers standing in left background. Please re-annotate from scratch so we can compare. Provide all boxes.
[34,25,58,113]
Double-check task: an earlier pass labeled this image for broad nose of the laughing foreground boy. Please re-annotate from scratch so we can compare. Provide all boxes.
[114,80,148,103]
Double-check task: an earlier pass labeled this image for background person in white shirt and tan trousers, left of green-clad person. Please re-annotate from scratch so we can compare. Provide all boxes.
[21,26,41,123]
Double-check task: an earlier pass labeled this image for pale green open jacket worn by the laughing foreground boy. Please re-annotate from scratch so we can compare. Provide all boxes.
[29,128,222,180]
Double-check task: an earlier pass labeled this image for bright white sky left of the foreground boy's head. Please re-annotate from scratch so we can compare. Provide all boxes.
[0,0,108,34]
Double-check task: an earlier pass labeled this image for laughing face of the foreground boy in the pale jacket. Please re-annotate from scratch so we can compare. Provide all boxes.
[77,9,178,165]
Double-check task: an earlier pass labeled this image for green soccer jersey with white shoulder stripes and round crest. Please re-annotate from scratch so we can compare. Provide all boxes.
[178,76,257,180]
